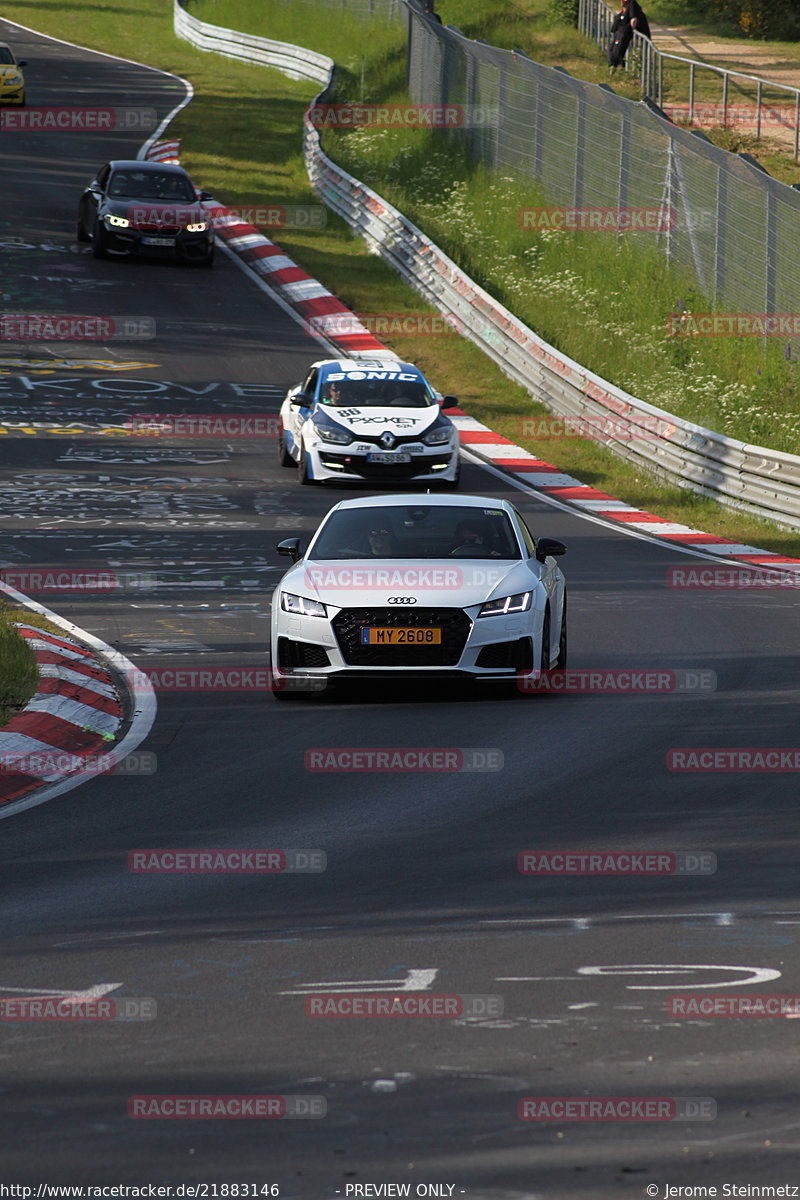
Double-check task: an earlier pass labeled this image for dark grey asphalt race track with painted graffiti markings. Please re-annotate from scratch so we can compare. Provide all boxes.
[0,22,800,1200]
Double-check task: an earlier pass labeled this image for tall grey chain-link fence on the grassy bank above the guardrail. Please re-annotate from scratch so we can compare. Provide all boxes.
[407,0,800,328]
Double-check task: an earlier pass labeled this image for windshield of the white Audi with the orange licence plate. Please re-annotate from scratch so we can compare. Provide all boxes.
[307,504,522,560]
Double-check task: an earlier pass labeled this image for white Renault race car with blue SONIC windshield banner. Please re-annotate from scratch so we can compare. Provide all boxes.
[278,359,459,487]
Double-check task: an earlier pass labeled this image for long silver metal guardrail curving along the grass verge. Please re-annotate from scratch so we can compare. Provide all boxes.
[174,0,800,529]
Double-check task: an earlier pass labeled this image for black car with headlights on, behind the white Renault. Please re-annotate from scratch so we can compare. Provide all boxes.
[78,160,215,266]
